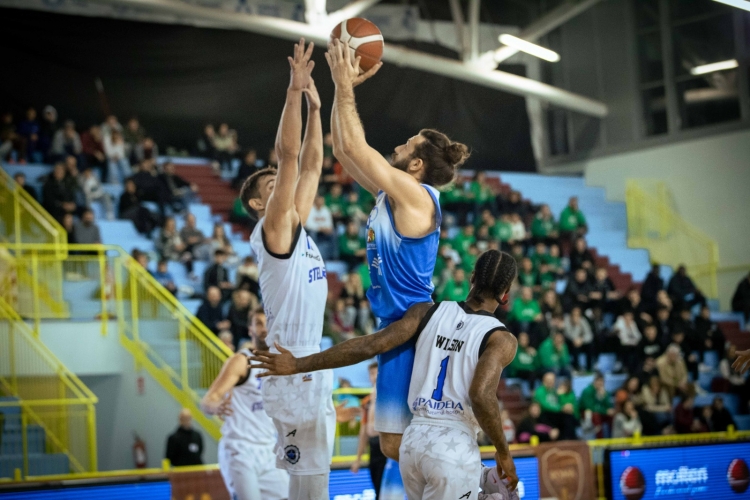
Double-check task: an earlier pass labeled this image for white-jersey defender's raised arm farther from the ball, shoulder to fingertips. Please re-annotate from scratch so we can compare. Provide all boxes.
[263,39,315,254]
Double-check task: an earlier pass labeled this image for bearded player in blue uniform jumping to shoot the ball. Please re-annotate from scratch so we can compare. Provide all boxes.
[326,40,469,460]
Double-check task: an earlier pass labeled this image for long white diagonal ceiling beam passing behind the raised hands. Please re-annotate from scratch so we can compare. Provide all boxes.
[85,0,607,118]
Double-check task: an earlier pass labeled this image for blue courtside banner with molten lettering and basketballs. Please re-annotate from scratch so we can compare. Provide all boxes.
[607,442,750,500]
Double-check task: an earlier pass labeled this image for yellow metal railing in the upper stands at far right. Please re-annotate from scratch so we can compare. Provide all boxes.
[625,179,719,298]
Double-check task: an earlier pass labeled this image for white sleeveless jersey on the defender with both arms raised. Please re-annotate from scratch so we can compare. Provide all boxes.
[250,217,328,355]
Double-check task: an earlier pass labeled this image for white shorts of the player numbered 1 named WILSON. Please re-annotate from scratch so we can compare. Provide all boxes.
[399,424,482,500]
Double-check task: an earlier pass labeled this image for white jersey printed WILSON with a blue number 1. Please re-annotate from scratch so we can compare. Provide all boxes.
[409,302,505,435]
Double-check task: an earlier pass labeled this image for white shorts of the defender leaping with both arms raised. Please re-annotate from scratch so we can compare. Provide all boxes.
[261,370,336,476]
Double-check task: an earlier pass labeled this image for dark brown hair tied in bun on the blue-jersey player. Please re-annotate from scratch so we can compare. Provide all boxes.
[412,129,471,188]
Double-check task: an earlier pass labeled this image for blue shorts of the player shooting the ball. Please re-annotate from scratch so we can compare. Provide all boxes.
[375,320,416,434]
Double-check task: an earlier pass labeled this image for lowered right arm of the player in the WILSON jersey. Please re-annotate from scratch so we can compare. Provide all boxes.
[469,330,518,491]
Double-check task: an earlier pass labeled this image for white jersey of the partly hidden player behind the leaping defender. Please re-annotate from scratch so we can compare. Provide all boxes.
[221,349,276,446]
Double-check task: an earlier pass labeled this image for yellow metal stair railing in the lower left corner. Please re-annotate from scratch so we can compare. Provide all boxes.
[0,297,98,477]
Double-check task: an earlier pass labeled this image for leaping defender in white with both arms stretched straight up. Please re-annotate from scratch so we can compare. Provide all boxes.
[240,40,335,500]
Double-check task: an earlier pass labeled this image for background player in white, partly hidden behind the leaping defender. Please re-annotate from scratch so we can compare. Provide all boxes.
[201,309,289,500]
